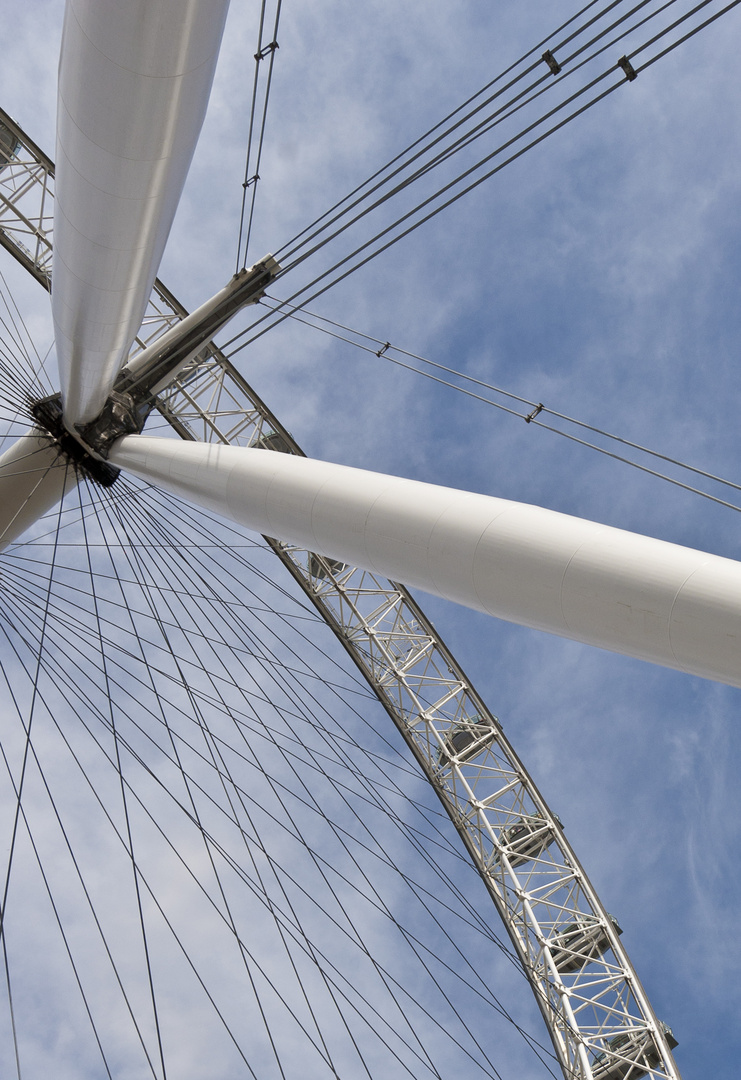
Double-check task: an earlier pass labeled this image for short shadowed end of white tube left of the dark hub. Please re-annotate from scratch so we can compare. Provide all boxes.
[0,429,77,551]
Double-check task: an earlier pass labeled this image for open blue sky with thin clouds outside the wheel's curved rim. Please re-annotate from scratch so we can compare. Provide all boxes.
[0,0,741,1080]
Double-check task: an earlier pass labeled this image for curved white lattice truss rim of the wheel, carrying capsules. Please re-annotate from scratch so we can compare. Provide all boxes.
[0,101,678,1080]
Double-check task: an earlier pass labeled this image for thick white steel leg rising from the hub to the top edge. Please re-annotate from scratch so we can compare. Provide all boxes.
[52,0,229,430]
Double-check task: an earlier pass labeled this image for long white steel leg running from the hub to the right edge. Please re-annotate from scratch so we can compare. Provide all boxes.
[110,435,741,686]
